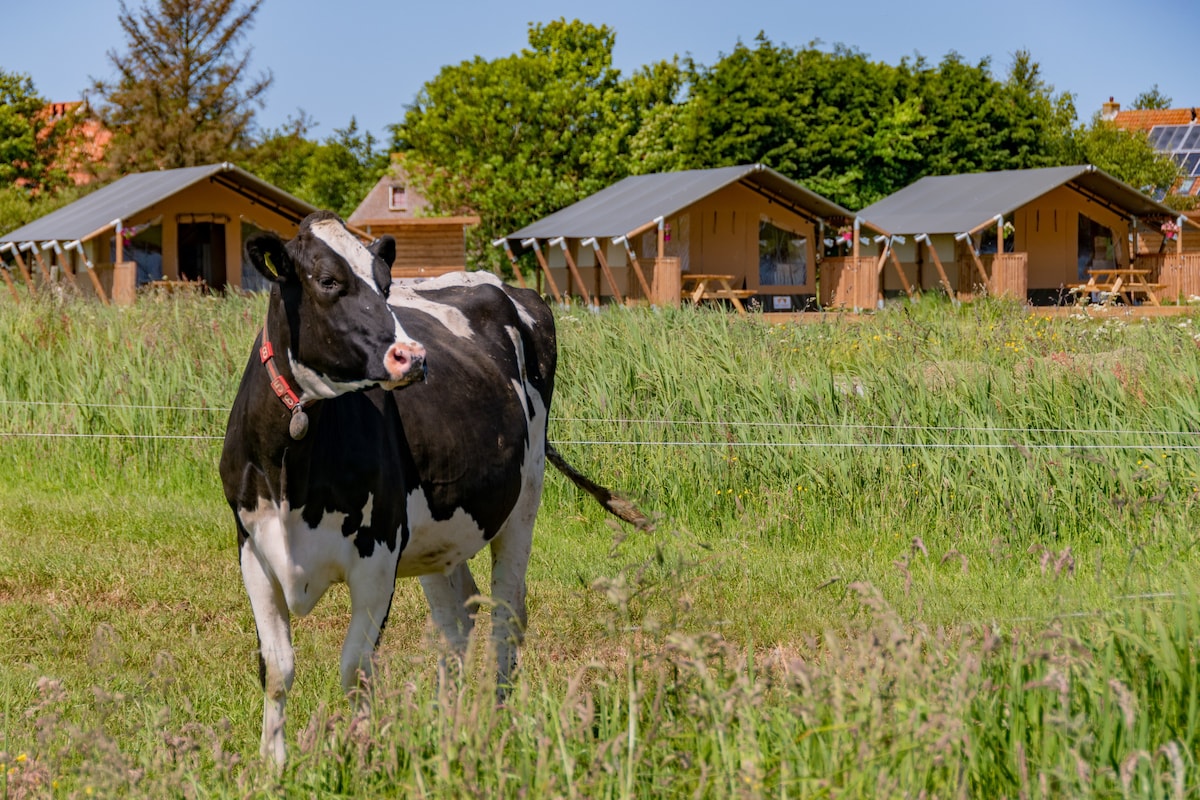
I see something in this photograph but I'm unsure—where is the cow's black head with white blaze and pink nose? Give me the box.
[246,211,425,401]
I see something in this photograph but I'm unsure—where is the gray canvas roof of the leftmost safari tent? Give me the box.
[0,163,317,242]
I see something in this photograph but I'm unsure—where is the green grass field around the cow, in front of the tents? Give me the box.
[0,291,1200,798]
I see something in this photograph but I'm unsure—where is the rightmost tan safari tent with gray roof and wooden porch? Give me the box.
[859,164,1200,305]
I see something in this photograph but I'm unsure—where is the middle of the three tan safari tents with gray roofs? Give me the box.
[497,164,876,311]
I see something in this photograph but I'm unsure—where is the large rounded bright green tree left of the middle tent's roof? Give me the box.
[392,19,678,273]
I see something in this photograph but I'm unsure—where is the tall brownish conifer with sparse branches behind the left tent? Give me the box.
[92,0,272,174]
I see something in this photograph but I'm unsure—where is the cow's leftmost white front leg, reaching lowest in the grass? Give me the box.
[241,539,295,766]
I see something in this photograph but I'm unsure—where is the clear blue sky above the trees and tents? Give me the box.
[0,0,1200,142]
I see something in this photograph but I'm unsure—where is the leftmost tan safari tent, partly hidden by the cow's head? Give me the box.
[0,163,317,303]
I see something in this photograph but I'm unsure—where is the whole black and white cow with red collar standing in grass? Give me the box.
[221,212,646,763]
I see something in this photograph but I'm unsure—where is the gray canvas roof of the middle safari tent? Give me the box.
[505,164,854,240]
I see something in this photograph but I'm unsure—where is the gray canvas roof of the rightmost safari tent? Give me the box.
[858,164,1176,235]
